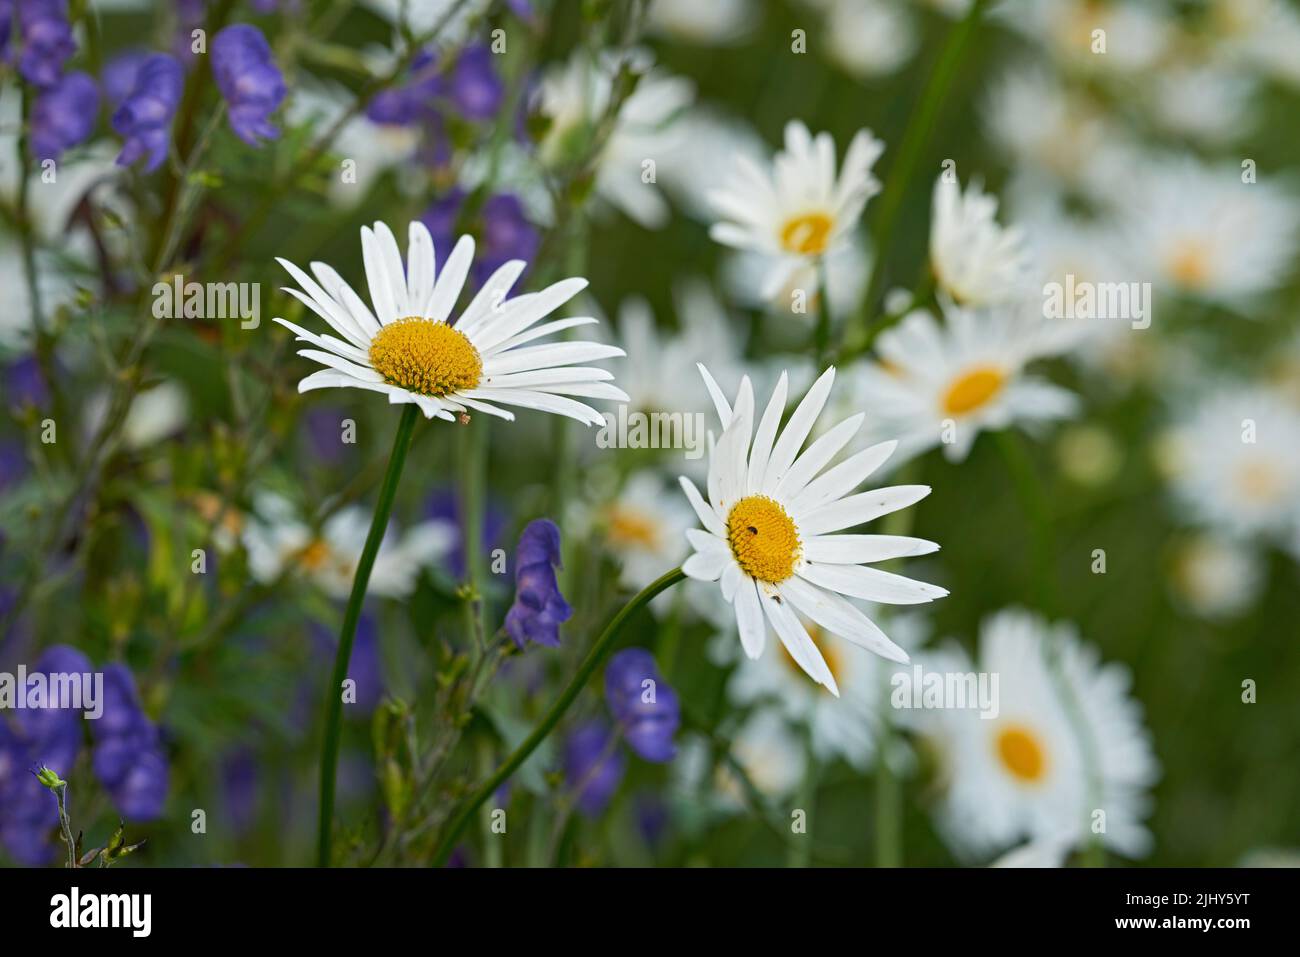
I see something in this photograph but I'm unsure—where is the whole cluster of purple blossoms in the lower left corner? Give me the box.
[0,645,168,865]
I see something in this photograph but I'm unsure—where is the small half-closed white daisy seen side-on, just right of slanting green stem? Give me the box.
[930,170,1031,306]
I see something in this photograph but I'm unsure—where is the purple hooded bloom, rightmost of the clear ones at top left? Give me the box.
[212,23,287,146]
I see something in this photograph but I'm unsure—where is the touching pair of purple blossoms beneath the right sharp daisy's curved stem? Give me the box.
[564,648,681,817]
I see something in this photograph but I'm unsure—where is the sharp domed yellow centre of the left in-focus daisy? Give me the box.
[371,316,484,395]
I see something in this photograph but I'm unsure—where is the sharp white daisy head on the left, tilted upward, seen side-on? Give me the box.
[276,222,628,425]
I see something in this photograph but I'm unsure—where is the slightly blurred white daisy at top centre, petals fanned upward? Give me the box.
[709,120,884,273]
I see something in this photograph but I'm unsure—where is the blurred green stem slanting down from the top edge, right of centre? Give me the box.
[849,0,987,355]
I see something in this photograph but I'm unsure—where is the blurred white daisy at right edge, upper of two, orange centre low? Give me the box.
[1123,159,1300,304]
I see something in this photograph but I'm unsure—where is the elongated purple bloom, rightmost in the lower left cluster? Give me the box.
[91,663,169,820]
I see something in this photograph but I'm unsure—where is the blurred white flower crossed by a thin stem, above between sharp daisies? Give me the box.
[538,51,696,229]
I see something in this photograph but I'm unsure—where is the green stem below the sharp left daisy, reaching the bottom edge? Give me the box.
[316,403,420,867]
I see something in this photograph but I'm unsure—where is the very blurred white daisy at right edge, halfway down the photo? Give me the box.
[1161,386,1300,540]
